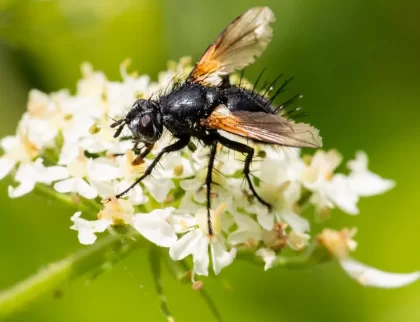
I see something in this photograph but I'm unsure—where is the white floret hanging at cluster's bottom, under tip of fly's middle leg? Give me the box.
[169,205,236,276]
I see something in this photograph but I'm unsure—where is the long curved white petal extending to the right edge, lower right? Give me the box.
[340,257,420,288]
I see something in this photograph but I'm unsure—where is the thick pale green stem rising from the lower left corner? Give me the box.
[0,234,144,321]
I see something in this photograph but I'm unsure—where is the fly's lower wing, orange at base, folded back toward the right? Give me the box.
[201,105,322,148]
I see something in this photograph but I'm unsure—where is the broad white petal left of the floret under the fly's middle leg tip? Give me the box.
[133,208,177,247]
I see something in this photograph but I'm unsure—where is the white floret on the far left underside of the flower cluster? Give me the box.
[8,158,69,198]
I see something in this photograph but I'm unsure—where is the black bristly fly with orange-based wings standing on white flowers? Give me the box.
[111,7,322,235]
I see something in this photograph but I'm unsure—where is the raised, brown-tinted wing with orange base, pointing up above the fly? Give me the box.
[188,7,275,86]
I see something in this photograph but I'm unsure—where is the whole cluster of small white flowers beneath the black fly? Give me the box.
[0,59,419,287]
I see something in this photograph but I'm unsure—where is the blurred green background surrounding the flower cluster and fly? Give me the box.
[0,0,420,322]
